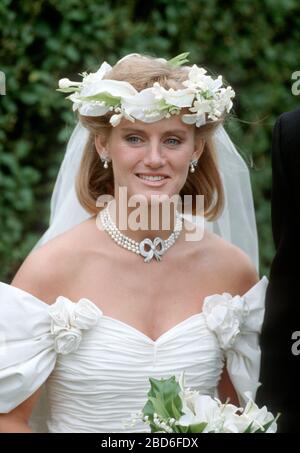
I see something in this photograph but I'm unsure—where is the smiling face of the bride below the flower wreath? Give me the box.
[95,116,204,202]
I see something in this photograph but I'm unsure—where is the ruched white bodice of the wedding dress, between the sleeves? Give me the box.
[47,314,223,432]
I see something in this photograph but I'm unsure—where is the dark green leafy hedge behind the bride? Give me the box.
[0,0,300,281]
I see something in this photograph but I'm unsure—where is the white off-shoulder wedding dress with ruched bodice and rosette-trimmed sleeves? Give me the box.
[0,277,268,433]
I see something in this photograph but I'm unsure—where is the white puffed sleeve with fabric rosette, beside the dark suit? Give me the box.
[203,277,268,405]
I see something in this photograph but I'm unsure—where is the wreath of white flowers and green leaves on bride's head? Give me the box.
[57,52,235,127]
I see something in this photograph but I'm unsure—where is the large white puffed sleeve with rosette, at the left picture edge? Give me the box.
[0,282,101,413]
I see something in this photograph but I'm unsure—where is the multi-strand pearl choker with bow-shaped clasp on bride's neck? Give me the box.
[100,206,183,263]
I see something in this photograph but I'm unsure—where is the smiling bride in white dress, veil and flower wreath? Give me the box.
[0,54,267,432]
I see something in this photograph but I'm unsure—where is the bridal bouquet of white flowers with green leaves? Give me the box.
[125,373,279,433]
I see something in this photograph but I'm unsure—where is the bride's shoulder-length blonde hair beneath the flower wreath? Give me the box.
[76,55,224,220]
